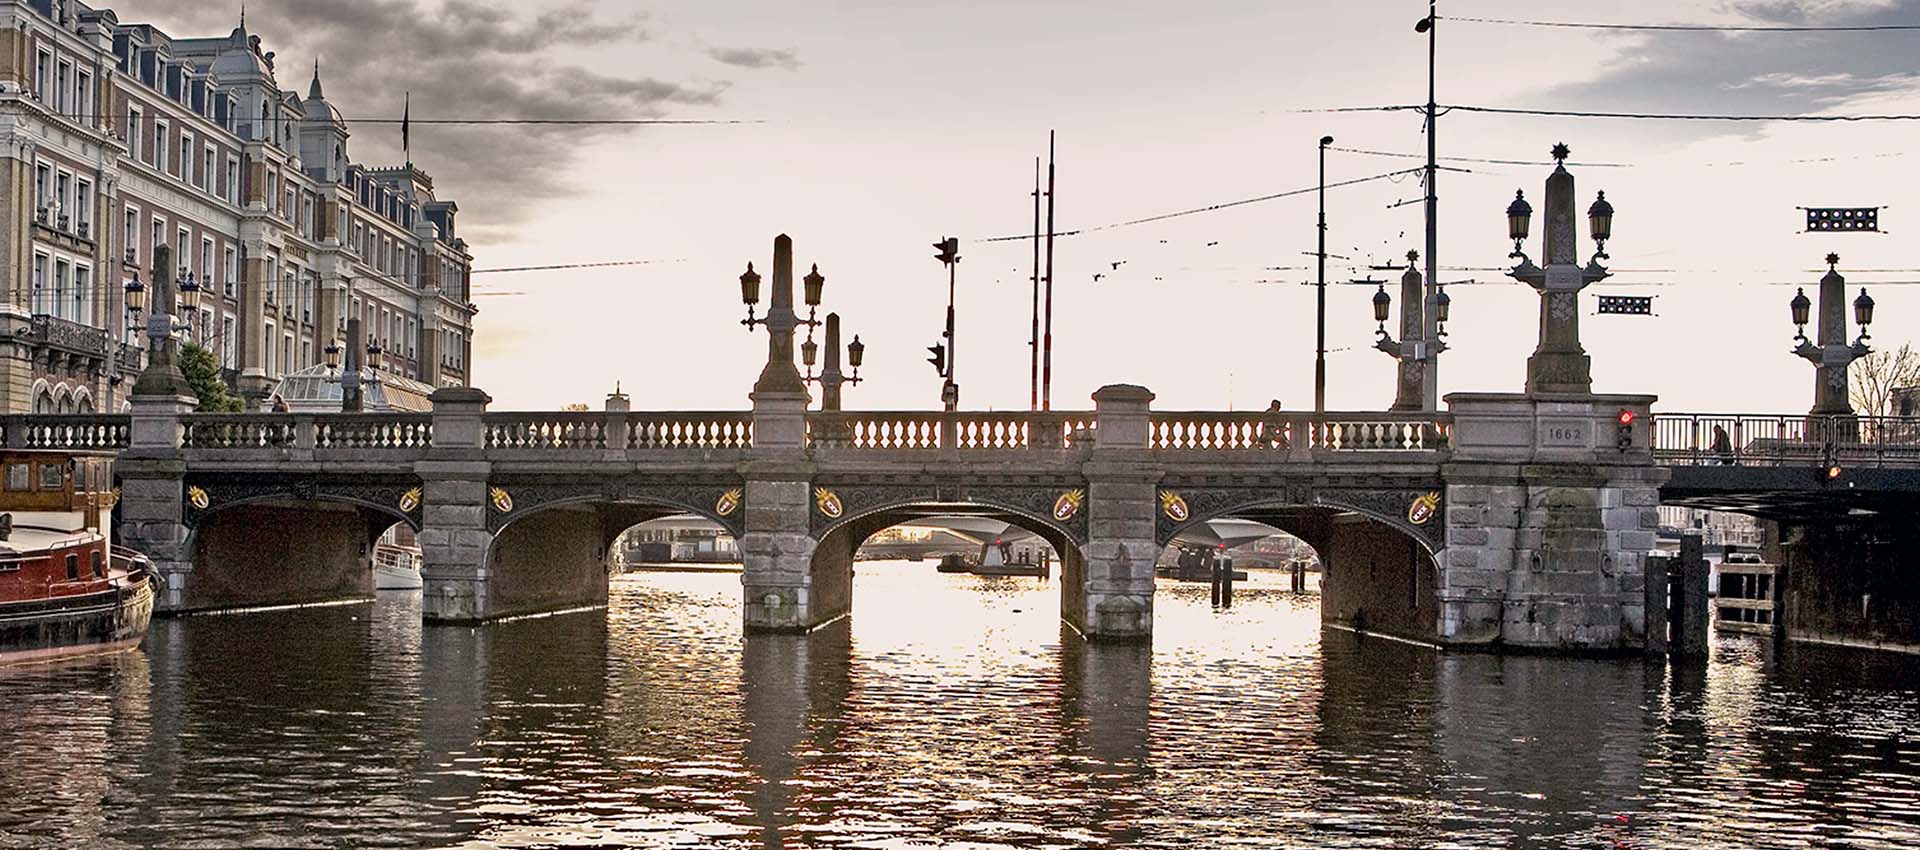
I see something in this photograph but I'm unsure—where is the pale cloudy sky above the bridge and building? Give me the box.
[127,0,1920,413]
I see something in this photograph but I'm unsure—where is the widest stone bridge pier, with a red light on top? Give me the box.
[1438,393,1667,652]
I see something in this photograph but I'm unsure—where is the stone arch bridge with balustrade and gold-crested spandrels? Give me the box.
[4,386,1668,650]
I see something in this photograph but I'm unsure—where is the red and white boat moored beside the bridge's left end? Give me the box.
[0,451,156,664]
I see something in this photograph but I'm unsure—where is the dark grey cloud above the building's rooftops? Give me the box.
[123,0,728,244]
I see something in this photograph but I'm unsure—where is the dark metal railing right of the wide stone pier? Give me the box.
[1653,413,1920,466]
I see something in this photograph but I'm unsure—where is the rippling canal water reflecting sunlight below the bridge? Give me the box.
[0,562,1920,850]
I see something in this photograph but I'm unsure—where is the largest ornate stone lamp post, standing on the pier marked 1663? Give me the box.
[1507,144,1613,393]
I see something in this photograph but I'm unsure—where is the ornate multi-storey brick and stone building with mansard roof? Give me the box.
[0,0,474,413]
